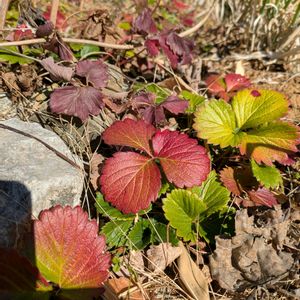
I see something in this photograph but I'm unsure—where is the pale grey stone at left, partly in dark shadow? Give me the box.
[0,119,84,247]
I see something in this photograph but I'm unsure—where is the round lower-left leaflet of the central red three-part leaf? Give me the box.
[100,152,161,214]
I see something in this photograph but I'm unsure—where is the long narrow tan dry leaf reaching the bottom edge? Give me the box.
[178,242,209,300]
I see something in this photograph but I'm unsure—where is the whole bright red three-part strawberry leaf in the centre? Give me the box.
[100,119,210,213]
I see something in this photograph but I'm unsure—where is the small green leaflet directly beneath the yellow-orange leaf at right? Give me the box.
[251,159,282,188]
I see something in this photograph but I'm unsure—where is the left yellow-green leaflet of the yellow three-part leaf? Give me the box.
[193,100,243,148]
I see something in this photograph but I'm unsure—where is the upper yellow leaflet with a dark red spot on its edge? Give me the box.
[232,89,288,130]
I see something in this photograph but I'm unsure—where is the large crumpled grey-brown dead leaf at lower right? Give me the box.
[210,208,294,291]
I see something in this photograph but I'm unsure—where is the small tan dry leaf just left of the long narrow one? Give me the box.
[147,243,181,273]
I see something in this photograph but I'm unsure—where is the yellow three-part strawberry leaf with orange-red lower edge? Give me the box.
[194,89,298,166]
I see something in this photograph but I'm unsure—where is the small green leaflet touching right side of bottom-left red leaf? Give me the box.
[100,220,133,248]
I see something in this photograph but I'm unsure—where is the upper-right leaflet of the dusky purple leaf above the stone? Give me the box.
[76,59,108,88]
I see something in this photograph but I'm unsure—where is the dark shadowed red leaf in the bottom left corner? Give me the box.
[0,248,52,299]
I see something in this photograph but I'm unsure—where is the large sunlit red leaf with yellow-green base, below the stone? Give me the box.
[34,205,110,292]
